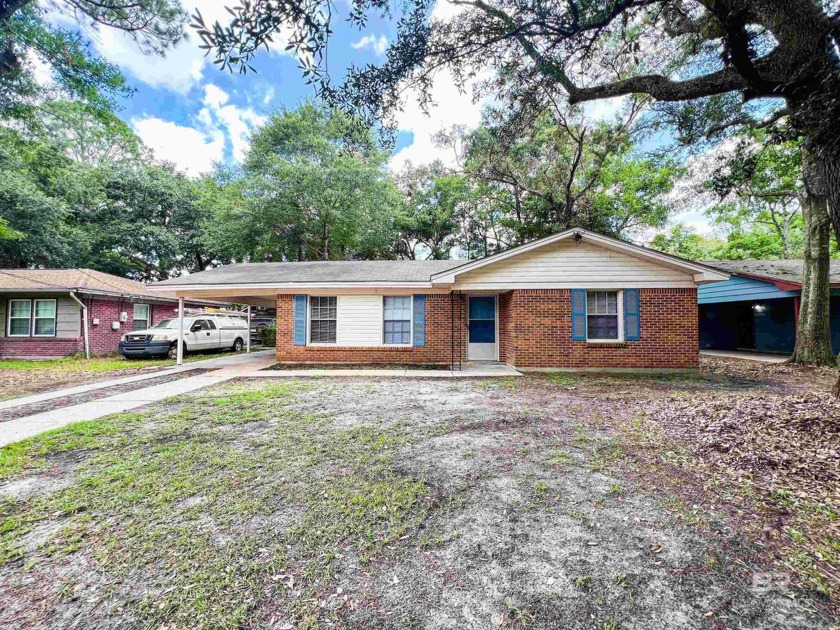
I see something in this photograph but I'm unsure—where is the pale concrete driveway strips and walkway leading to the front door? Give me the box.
[0,350,521,447]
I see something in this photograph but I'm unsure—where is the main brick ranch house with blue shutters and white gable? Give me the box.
[150,229,729,370]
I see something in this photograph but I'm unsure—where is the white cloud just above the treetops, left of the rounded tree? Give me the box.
[131,117,225,177]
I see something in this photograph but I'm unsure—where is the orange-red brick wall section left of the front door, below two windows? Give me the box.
[277,294,466,364]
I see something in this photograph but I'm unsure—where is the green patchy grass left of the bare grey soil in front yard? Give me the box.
[0,381,454,627]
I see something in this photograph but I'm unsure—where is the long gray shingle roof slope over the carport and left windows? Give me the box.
[155,260,469,287]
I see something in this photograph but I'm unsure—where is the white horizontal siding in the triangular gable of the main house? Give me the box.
[455,240,695,289]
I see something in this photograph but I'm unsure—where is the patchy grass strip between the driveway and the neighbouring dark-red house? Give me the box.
[0,353,230,400]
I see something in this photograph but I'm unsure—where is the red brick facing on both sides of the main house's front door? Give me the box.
[276,289,699,369]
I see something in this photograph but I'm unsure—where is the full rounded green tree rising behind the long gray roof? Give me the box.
[206,102,399,261]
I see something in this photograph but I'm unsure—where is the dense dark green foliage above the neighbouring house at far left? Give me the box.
[0,123,225,280]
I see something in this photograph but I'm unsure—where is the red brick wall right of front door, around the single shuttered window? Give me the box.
[500,289,699,368]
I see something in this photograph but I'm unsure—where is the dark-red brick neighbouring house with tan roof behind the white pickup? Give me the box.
[0,269,217,359]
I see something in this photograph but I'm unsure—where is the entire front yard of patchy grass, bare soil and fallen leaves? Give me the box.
[0,360,840,630]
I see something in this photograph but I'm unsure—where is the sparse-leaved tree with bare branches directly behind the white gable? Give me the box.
[440,103,680,253]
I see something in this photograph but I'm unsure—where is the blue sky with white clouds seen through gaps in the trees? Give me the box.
[46,0,709,238]
